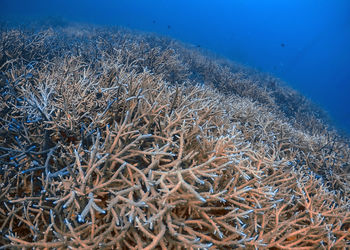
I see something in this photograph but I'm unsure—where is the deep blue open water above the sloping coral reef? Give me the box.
[0,0,350,133]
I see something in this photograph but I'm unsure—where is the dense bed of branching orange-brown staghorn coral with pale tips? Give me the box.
[0,26,350,249]
